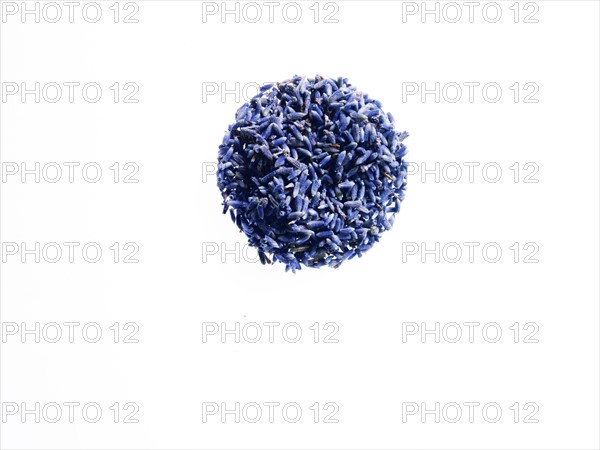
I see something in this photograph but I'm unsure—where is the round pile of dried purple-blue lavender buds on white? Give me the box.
[217,76,408,271]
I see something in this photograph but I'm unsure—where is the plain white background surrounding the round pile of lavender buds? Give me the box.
[0,1,600,449]
